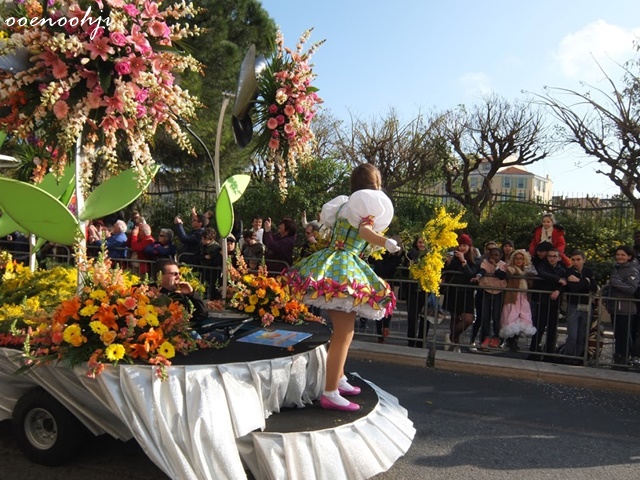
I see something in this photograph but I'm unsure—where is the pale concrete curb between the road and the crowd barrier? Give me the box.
[349,340,640,395]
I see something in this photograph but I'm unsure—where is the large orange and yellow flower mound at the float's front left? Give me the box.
[24,253,224,379]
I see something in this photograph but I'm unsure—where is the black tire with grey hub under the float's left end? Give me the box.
[13,388,89,466]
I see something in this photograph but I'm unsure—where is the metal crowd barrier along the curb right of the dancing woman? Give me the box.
[356,270,640,369]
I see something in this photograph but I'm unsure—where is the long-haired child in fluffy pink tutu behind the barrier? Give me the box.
[500,249,536,350]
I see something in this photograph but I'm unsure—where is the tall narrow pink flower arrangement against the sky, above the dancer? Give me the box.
[256,30,324,192]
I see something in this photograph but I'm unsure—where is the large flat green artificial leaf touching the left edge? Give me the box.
[0,178,81,245]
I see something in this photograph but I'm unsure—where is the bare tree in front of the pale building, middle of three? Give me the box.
[437,95,550,217]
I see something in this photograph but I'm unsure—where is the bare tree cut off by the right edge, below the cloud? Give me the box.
[539,64,640,220]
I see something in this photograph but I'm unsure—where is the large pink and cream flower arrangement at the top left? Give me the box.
[0,0,202,183]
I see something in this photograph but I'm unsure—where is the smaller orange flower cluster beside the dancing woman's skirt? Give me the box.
[227,256,324,327]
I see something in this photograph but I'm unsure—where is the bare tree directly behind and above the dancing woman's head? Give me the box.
[336,109,445,192]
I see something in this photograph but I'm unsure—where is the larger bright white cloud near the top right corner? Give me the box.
[554,20,640,83]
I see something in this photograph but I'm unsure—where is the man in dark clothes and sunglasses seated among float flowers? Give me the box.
[156,258,208,328]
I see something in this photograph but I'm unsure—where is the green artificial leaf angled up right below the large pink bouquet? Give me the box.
[79,165,160,220]
